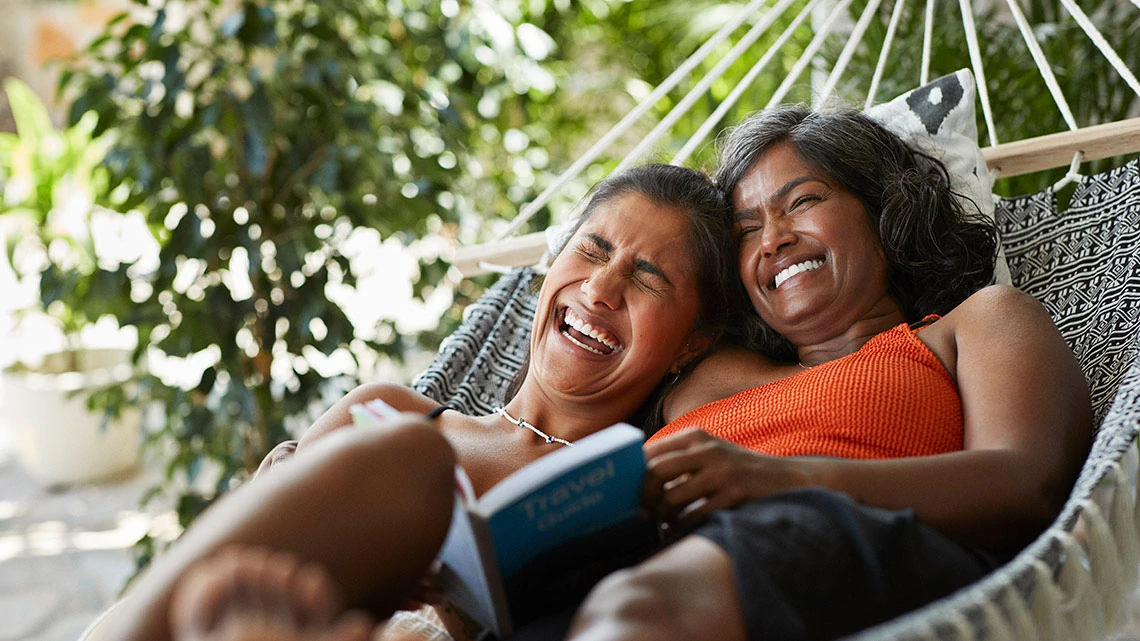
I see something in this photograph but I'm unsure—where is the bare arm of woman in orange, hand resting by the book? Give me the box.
[646,287,1091,550]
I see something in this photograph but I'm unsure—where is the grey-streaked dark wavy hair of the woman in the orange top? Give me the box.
[714,105,998,360]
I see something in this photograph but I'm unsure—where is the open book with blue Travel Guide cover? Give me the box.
[350,401,657,638]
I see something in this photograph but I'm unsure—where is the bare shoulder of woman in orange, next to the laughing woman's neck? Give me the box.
[663,347,782,422]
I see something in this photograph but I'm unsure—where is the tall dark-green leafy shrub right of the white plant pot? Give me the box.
[60,0,656,542]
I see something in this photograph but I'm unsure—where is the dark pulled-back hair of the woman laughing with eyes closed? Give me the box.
[504,164,748,433]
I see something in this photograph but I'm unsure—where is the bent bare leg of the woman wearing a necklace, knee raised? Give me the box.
[89,416,455,641]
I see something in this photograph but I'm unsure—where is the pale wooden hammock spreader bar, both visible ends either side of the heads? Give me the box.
[451,117,1140,278]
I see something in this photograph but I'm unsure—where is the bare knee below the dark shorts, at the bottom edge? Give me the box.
[567,535,746,641]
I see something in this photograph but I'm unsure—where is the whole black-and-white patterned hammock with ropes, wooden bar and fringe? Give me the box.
[414,0,1140,641]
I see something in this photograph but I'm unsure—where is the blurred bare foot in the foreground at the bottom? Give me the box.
[170,547,373,641]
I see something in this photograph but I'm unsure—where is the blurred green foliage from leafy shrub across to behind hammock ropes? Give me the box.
[46,0,1140,563]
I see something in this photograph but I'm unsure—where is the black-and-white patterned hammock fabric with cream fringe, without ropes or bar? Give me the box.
[414,161,1140,641]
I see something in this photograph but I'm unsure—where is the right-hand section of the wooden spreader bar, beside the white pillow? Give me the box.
[982,117,1140,178]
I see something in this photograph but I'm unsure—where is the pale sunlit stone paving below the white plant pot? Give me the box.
[0,432,1140,641]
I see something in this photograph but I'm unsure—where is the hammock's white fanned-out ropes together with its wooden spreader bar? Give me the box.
[453,0,1140,276]
